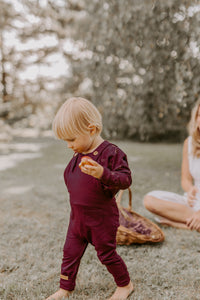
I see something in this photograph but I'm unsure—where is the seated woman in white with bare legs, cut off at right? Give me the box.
[144,99,200,232]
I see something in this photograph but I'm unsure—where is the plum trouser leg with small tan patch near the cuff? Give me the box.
[60,234,88,291]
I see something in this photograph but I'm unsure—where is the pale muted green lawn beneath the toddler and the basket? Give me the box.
[0,139,200,300]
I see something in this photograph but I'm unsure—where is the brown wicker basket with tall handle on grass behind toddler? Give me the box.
[116,188,165,245]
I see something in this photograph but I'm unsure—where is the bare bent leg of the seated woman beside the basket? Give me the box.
[144,194,194,228]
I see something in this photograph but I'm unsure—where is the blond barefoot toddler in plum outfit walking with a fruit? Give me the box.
[47,98,133,300]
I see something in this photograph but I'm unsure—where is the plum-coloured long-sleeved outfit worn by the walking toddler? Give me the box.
[60,141,132,291]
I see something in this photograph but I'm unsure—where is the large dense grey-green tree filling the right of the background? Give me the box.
[69,0,200,141]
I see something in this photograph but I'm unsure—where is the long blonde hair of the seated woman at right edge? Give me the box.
[188,99,200,157]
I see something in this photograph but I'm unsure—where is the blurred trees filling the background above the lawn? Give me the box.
[0,0,200,141]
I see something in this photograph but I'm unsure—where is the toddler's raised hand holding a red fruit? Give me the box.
[79,157,103,179]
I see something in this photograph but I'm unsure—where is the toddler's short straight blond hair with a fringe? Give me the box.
[52,97,102,140]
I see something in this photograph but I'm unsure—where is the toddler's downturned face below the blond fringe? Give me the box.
[66,131,94,153]
